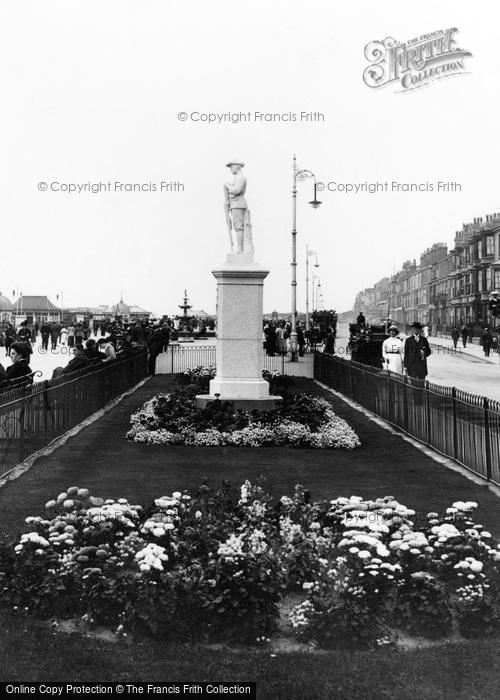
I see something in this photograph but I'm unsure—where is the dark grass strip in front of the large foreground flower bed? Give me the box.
[0,615,500,700]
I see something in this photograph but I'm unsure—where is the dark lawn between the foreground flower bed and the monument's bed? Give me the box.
[0,376,500,539]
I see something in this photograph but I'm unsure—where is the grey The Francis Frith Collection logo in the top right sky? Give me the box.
[363,27,472,92]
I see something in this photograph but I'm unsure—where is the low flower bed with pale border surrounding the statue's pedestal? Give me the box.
[127,389,361,450]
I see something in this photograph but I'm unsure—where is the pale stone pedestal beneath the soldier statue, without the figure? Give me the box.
[196,253,281,410]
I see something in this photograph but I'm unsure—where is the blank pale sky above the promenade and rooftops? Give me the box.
[0,0,500,314]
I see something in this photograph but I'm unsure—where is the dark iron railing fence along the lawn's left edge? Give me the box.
[0,351,147,476]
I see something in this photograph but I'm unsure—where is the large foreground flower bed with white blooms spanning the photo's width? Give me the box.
[0,482,500,646]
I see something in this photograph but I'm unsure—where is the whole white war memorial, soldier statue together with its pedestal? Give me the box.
[196,160,281,410]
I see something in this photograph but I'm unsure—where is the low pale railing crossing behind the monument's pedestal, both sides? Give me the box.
[156,345,314,378]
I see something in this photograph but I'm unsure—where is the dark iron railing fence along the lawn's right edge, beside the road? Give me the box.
[314,353,500,485]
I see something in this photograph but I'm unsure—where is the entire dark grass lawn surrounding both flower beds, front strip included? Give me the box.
[0,377,500,700]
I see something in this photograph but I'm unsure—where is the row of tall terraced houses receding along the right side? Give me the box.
[354,212,500,334]
